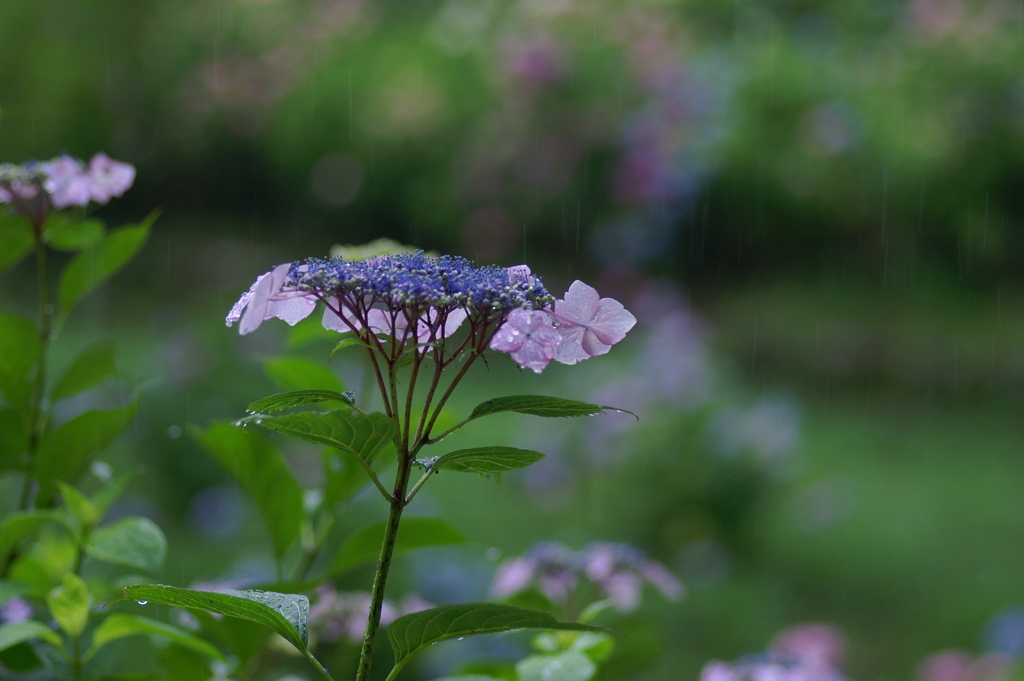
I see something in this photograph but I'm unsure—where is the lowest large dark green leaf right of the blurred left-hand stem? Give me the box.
[36,401,138,505]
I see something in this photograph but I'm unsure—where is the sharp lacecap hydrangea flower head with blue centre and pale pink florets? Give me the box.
[226,251,636,373]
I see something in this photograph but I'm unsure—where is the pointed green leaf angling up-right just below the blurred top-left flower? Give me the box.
[58,212,158,317]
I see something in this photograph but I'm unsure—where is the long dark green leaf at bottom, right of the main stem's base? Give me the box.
[387,603,606,677]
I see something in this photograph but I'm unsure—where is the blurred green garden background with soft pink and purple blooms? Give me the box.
[0,0,1024,679]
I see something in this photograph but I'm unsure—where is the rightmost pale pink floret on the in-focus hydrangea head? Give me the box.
[554,280,637,365]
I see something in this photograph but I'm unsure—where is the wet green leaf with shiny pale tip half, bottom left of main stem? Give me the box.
[114,584,309,653]
